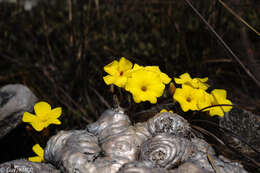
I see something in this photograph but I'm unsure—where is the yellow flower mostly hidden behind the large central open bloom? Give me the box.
[132,64,171,84]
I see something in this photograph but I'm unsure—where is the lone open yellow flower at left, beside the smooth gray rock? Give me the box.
[23,102,62,131]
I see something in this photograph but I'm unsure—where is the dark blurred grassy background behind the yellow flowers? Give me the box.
[0,0,260,172]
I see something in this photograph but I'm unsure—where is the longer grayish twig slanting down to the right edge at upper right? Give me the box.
[185,0,260,87]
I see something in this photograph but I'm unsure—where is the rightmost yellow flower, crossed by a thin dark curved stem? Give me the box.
[203,89,232,117]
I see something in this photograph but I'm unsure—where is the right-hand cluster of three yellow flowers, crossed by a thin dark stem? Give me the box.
[173,73,232,116]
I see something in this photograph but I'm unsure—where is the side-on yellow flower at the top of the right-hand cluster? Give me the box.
[174,73,209,90]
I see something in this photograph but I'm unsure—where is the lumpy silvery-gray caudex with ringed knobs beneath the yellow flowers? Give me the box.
[0,108,246,173]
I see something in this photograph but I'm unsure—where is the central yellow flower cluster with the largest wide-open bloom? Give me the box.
[103,57,171,103]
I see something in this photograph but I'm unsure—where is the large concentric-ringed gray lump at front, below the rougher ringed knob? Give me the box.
[140,133,194,169]
